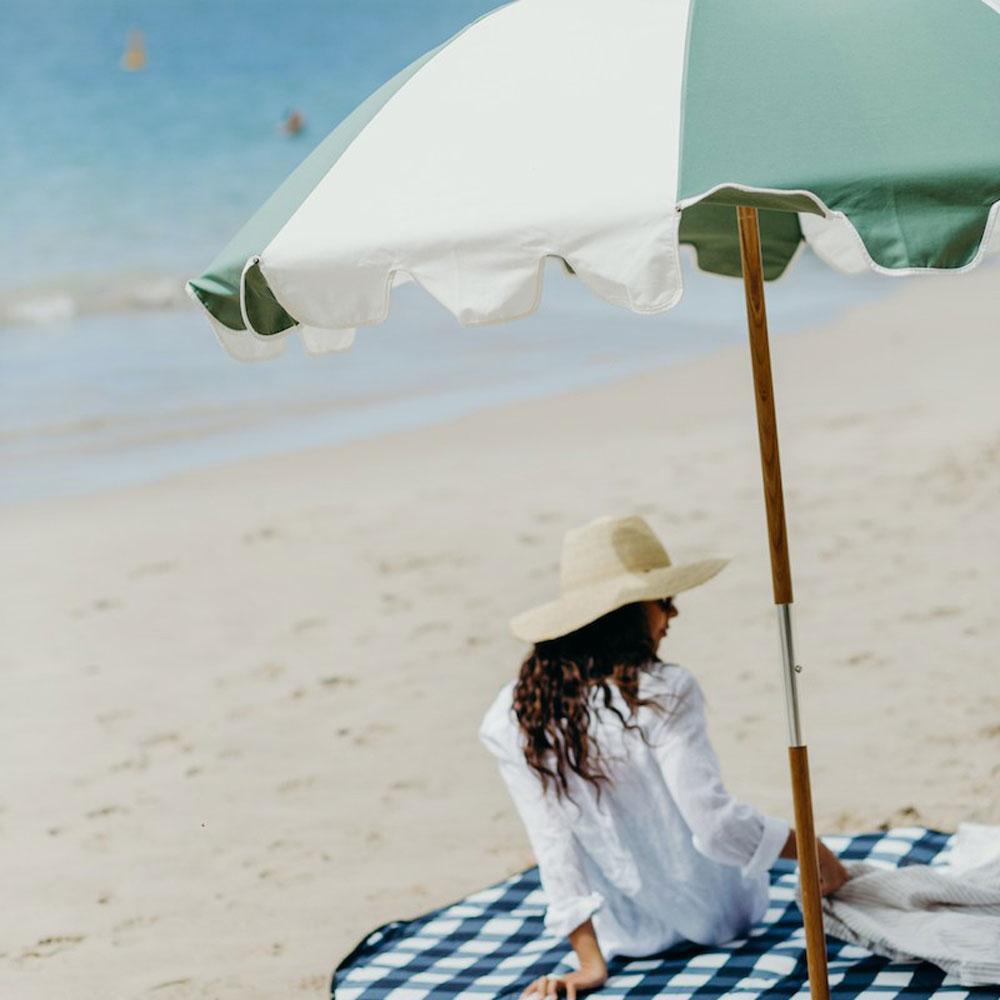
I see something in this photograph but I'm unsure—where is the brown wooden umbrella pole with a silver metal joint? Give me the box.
[736,205,830,1000]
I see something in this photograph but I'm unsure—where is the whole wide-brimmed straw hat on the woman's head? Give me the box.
[510,517,729,642]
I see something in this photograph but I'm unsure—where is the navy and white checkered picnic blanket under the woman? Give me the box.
[332,827,1000,1000]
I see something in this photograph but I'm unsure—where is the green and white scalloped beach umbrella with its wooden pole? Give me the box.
[188,0,1000,997]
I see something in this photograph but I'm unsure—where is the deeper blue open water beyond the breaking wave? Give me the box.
[0,0,497,298]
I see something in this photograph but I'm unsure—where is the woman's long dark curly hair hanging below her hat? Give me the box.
[513,604,663,798]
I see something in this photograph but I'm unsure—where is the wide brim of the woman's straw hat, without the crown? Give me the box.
[510,559,729,642]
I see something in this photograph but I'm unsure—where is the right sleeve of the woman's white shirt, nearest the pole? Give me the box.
[652,671,789,877]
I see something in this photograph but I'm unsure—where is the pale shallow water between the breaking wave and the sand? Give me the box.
[0,250,892,507]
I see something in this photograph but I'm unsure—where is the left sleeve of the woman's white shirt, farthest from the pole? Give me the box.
[479,723,604,937]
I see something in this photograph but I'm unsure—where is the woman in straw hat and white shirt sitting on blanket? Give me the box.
[480,517,847,1000]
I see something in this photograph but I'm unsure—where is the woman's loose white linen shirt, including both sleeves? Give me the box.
[479,663,789,959]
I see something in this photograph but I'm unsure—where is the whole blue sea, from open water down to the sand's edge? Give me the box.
[0,0,896,503]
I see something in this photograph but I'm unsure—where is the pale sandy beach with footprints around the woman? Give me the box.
[0,266,1000,1000]
